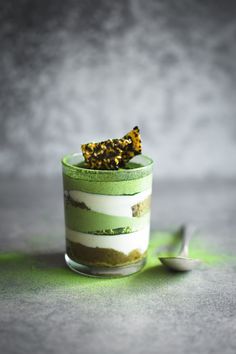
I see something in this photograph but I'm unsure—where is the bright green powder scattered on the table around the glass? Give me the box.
[0,232,236,298]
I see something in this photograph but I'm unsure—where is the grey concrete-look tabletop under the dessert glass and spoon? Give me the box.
[0,178,236,354]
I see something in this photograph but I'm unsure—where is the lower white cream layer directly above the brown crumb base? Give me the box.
[66,225,149,255]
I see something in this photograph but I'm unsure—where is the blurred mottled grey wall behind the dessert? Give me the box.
[0,0,236,178]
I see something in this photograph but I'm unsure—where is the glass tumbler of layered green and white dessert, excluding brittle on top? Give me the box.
[62,127,153,277]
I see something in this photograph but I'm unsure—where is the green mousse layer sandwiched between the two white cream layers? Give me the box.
[65,204,150,233]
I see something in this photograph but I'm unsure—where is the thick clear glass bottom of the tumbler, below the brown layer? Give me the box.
[65,254,146,278]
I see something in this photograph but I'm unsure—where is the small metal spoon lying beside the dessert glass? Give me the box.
[159,226,201,272]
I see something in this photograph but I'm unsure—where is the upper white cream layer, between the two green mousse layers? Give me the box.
[69,189,152,217]
